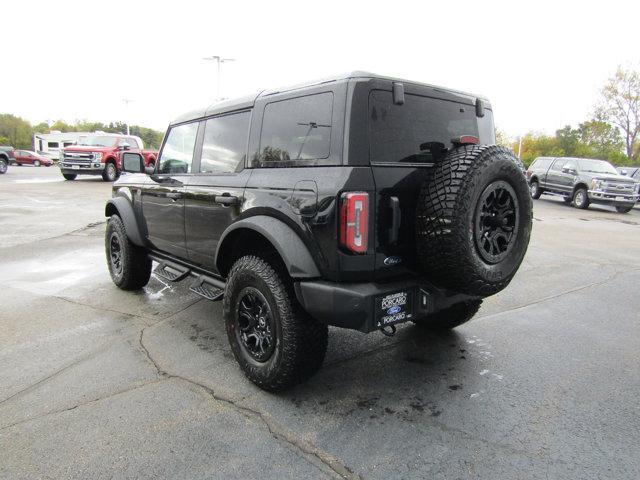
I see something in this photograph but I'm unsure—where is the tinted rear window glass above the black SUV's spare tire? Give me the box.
[369,90,495,163]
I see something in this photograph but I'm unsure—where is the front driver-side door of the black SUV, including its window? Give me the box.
[142,122,198,259]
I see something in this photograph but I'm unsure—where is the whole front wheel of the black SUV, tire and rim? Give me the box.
[104,215,151,290]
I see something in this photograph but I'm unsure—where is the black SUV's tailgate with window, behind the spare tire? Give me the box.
[368,89,495,278]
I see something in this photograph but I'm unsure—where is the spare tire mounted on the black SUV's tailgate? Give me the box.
[416,145,532,297]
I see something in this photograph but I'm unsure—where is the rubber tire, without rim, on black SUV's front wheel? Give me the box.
[105,215,152,290]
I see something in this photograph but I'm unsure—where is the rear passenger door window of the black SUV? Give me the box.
[200,112,251,173]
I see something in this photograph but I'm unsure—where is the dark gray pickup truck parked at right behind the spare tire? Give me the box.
[527,157,640,213]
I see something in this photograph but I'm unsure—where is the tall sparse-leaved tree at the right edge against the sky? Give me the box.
[596,67,640,163]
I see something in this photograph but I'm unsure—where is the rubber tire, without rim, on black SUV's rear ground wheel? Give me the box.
[222,255,328,392]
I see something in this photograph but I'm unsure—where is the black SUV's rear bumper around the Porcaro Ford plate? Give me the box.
[295,278,477,333]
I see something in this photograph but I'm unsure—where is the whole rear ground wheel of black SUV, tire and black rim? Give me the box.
[222,256,328,392]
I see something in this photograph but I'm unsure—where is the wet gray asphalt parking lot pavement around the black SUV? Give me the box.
[0,167,640,480]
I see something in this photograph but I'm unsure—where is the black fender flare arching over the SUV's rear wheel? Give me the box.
[215,215,320,278]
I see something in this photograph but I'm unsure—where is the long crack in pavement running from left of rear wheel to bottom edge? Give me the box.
[139,323,362,480]
